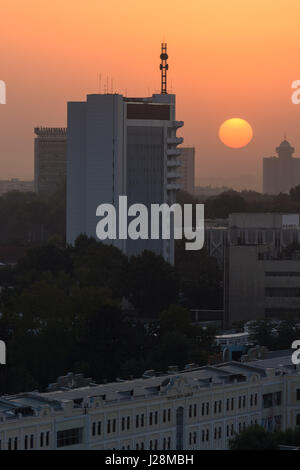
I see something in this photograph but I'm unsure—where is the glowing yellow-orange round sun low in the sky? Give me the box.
[219,118,253,148]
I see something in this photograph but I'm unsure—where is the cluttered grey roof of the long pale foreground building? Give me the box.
[0,351,299,418]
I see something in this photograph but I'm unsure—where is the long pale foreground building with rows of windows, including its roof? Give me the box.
[0,356,300,450]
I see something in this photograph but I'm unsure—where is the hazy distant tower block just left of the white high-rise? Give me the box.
[34,127,67,195]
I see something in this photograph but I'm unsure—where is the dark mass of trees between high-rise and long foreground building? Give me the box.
[0,236,218,393]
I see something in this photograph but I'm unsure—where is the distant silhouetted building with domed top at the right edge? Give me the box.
[263,140,300,194]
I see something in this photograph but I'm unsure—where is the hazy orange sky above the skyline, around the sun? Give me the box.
[0,0,300,188]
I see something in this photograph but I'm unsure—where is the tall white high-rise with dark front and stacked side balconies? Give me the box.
[67,93,183,263]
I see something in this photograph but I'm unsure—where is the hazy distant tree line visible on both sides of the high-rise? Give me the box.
[0,185,300,246]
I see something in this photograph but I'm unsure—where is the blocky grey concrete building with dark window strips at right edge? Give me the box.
[225,214,300,326]
